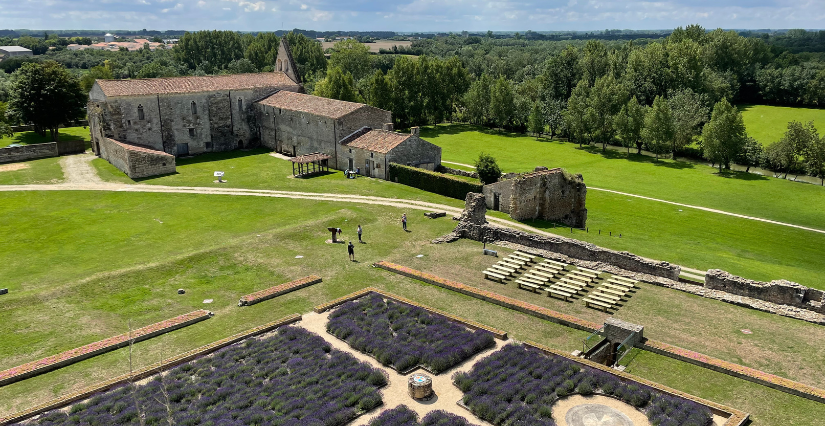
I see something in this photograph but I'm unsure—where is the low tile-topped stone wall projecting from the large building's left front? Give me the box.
[100,138,175,179]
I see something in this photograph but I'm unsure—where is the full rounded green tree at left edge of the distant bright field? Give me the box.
[702,99,748,171]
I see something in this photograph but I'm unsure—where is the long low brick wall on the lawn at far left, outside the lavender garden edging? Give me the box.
[0,309,212,387]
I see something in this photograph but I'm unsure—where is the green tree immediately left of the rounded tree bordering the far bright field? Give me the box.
[667,89,708,158]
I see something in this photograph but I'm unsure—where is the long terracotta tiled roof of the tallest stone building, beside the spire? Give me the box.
[97,72,295,96]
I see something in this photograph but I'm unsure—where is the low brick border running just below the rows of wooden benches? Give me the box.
[374,261,602,332]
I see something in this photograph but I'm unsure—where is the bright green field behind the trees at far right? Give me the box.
[738,104,825,146]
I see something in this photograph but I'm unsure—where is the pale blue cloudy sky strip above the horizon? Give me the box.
[0,0,825,32]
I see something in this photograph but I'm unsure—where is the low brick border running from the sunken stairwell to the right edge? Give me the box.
[640,340,825,403]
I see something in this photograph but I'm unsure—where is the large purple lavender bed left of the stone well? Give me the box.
[26,327,387,426]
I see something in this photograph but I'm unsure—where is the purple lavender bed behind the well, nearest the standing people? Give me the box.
[327,294,495,374]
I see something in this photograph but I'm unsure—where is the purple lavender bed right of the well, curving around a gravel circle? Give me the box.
[453,345,712,426]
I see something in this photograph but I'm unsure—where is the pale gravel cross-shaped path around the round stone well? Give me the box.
[297,311,504,426]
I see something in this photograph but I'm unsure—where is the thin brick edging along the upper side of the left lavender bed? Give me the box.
[0,314,301,426]
